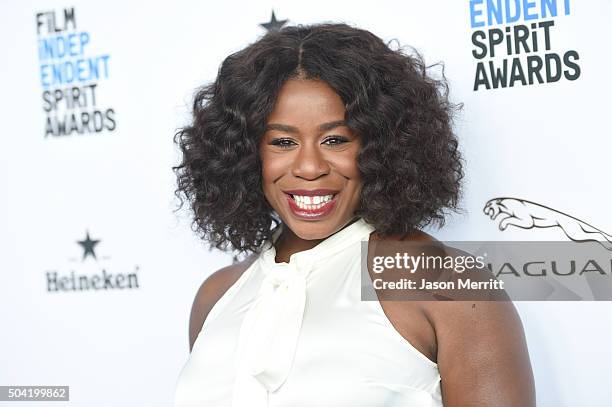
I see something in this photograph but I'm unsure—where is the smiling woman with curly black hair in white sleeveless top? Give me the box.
[175,24,534,407]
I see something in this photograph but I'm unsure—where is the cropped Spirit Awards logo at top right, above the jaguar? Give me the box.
[467,0,581,91]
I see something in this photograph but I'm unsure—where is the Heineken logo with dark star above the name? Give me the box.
[45,231,140,293]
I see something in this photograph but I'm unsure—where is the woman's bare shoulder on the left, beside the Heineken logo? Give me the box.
[189,254,257,350]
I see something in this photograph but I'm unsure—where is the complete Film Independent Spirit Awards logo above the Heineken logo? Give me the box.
[35,7,117,138]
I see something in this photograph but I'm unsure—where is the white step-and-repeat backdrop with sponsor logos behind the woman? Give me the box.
[0,0,612,407]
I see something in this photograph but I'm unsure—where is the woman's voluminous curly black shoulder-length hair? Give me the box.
[173,24,463,252]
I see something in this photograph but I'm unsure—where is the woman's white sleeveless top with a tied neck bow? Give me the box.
[174,219,442,407]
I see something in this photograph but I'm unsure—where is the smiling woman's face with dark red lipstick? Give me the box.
[260,79,361,240]
